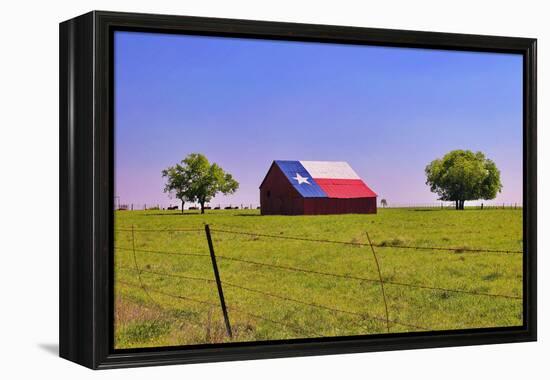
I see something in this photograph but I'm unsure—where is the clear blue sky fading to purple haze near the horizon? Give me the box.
[115,32,523,206]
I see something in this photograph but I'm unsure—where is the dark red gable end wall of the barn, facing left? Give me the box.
[260,165,304,215]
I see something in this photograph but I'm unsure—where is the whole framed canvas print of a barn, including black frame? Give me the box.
[60,11,537,369]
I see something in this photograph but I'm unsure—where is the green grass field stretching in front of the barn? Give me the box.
[115,209,523,348]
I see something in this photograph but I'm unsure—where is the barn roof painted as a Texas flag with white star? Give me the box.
[275,160,376,198]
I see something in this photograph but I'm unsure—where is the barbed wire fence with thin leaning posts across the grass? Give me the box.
[114,224,523,339]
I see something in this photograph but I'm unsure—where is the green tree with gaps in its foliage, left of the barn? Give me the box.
[162,153,239,214]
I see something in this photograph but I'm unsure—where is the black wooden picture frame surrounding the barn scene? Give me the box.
[59,11,537,369]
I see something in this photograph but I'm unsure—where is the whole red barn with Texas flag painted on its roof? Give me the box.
[260,160,377,215]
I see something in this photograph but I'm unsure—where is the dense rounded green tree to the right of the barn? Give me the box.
[425,150,502,210]
